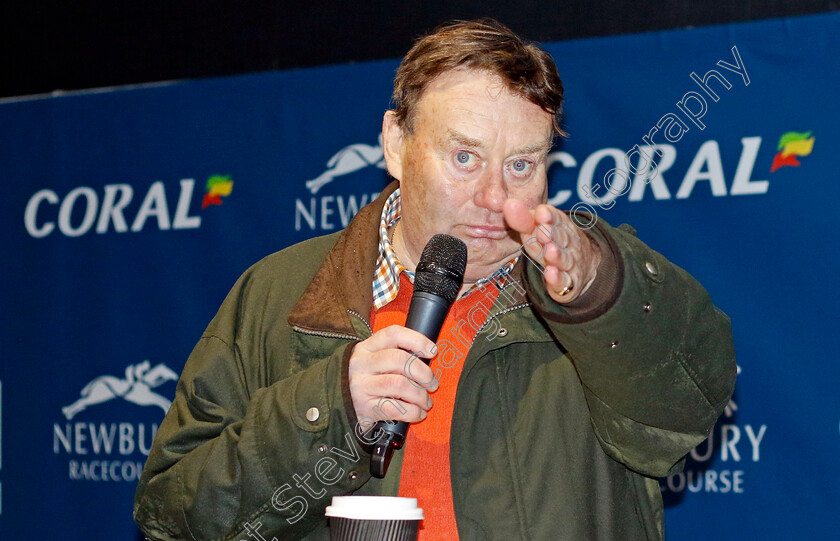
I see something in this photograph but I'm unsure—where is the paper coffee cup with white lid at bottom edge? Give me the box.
[326,496,423,541]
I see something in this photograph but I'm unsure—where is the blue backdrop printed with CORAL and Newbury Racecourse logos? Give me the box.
[0,10,840,540]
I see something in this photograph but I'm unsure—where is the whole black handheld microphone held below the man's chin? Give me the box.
[370,234,467,479]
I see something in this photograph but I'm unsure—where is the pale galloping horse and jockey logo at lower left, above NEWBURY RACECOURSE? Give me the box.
[61,361,178,421]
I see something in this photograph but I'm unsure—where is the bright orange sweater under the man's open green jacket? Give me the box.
[371,272,499,541]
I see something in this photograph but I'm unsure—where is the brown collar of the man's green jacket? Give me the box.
[288,181,525,337]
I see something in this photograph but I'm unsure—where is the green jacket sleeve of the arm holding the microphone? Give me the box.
[134,255,367,541]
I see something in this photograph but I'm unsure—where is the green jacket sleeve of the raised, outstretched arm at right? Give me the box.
[525,220,736,477]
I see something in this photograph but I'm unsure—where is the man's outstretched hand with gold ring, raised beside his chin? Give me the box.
[503,199,601,303]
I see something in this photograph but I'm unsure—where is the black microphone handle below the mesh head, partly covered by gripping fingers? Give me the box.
[370,291,451,479]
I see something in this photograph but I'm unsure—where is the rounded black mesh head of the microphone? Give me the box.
[414,234,467,303]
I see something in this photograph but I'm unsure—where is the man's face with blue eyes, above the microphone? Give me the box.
[383,69,552,283]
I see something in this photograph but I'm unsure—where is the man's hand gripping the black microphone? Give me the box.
[349,325,438,429]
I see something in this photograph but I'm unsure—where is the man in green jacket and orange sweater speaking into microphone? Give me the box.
[135,21,735,540]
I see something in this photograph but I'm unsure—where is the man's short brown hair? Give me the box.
[393,18,566,136]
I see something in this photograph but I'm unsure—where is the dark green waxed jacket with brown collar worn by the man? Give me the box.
[134,185,735,541]
